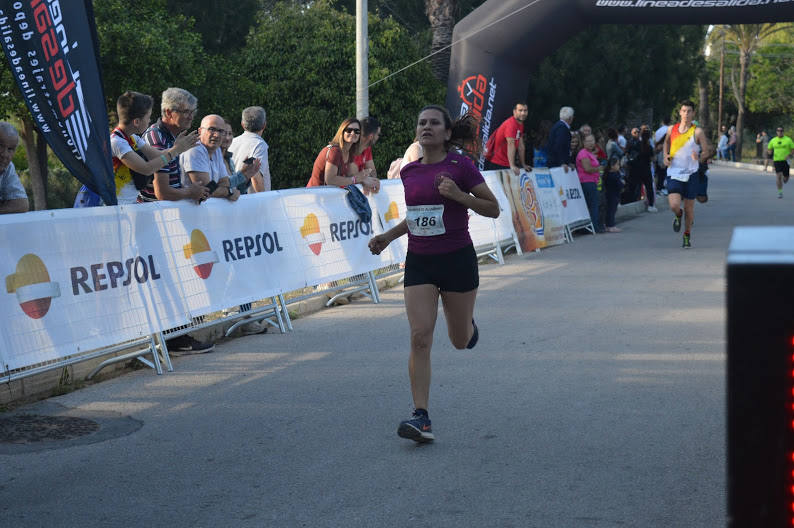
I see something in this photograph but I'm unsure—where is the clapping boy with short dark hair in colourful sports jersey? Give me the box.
[110,91,197,205]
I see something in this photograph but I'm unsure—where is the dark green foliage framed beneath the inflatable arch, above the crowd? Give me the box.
[527,25,705,128]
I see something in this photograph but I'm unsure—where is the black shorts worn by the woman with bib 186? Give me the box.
[403,245,480,293]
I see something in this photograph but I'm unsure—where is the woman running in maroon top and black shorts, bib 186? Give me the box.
[369,105,499,442]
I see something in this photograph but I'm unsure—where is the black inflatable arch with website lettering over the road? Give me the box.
[446,0,794,164]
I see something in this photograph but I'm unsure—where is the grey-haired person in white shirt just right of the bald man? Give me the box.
[229,106,272,192]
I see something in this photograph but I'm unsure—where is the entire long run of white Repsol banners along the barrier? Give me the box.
[0,184,511,371]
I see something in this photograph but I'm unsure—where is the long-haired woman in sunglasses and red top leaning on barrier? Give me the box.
[306,117,378,190]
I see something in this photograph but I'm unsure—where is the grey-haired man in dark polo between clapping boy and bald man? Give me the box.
[138,88,209,202]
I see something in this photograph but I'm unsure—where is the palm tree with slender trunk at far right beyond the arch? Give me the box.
[709,23,794,159]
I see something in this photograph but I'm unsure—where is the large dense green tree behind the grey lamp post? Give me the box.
[238,1,444,188]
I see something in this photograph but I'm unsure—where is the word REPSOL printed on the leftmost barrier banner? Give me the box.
[69,255,160,295]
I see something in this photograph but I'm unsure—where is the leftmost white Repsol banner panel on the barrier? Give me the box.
[0,207,189,369]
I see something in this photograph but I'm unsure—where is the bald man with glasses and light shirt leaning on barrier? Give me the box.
[179,114,240,202]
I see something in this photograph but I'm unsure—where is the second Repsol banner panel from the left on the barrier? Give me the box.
[150,193,296,318]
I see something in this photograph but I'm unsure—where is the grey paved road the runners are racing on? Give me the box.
[0,164,794,528]
